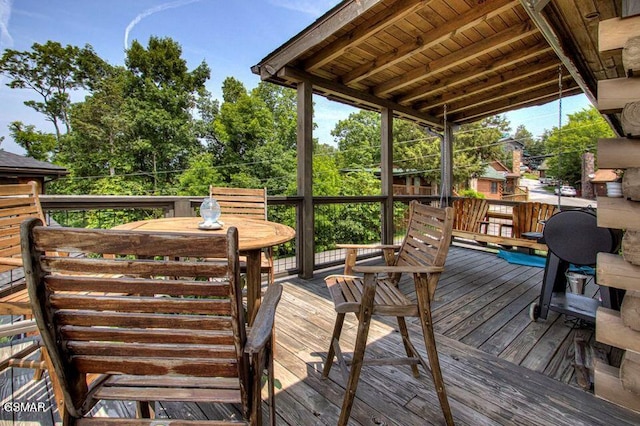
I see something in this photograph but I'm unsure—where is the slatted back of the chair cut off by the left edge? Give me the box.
[0,182,44,272]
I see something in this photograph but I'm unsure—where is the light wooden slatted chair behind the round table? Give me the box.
[209,186,275,284]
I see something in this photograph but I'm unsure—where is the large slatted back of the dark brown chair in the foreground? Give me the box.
[22,220,249,418]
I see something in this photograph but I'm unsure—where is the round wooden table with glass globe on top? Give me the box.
[113,215,296,319]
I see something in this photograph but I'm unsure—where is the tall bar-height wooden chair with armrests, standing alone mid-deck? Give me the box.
[322,201,453,425]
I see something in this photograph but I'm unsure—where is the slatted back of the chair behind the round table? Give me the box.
[210,186,267,220]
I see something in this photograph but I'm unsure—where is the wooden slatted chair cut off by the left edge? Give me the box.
[0,182,45,379]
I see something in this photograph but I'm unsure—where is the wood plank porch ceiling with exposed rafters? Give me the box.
[252,0,624,133]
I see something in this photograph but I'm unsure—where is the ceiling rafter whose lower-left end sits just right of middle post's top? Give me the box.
[396,43,553,105]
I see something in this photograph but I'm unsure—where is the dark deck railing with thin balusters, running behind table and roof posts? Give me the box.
[40,195,544,274]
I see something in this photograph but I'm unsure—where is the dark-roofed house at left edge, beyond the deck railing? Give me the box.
[0,150,69,193]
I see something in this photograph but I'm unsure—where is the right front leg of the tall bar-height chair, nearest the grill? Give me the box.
[416,280,453,426]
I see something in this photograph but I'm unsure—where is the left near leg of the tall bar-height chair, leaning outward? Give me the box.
[338,274,376,426]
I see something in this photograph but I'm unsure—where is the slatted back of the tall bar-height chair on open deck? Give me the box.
[396,201,454,297]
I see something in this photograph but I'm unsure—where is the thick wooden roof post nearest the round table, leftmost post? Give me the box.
[296,81,315,278]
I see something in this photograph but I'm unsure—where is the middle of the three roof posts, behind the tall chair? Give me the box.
[380,108,393,244]
